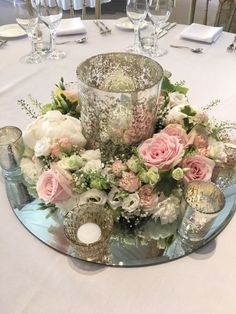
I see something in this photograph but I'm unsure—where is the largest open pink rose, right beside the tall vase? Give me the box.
[138,132,184,170]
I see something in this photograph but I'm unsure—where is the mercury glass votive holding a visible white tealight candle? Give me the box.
[64,203,113,261]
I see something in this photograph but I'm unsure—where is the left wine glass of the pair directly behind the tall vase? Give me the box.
[126,0,147,52]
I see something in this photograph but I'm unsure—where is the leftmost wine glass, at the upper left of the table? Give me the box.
[14,0,42,63]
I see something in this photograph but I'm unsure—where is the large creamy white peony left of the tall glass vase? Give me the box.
[23,110,86,155]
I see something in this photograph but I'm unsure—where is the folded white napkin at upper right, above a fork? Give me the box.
[180,23,223,43]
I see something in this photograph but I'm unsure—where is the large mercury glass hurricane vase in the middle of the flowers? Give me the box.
[77,53,163,151]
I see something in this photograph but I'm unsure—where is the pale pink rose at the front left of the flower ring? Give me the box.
[36,167,72,204]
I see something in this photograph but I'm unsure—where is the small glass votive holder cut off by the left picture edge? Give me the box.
[0,126,24,178]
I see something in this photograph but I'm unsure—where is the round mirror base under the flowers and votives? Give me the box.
[6,181,236,267]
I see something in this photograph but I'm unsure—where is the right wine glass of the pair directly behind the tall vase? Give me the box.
[147,0,173,58]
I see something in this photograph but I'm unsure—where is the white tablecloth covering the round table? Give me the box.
[0,21,236,314]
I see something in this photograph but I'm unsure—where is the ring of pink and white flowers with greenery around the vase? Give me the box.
[19,77,235,243]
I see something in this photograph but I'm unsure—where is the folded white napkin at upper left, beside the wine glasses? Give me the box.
[57,17,86,36]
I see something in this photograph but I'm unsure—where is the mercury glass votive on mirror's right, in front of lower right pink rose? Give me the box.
[178,181,225,242]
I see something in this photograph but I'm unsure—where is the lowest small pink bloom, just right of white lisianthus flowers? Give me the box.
[138,184,158,211]
